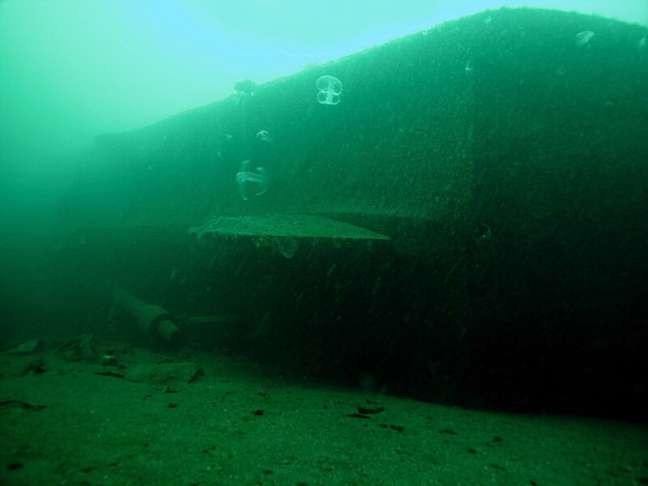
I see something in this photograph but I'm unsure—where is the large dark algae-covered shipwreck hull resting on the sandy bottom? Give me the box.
[63,9,648,416]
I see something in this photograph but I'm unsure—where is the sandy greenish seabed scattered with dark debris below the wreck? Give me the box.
[0,343,648,486]
